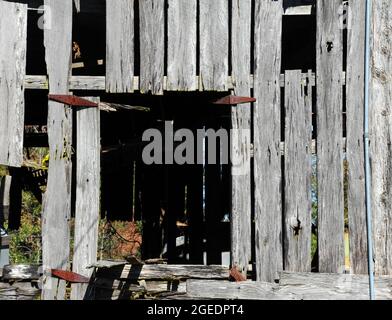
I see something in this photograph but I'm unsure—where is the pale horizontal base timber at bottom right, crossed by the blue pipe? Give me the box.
[187,272,392,300]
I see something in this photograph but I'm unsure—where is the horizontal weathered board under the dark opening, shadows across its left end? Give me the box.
[97,262,229,280]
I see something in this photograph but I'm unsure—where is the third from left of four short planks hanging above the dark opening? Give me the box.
[167,0,197,91]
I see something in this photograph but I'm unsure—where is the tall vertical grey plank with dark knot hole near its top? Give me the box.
[316,0,344,273]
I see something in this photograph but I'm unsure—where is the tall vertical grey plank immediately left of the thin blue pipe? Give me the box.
[346,1,368,274]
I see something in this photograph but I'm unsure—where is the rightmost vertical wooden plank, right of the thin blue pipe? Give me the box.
[370,0,392,275]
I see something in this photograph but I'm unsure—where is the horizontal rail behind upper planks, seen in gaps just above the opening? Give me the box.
[25,72,346,91]
